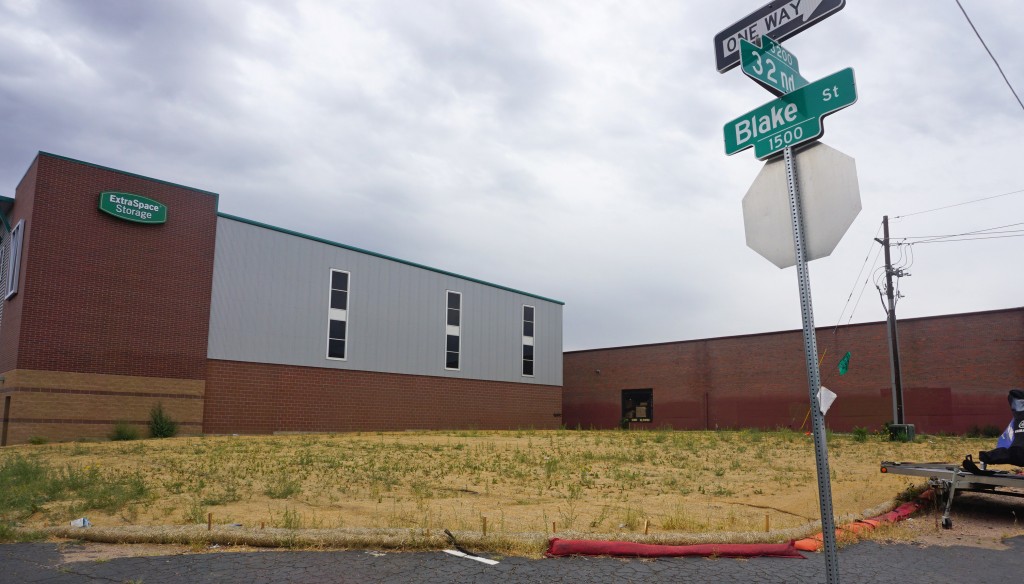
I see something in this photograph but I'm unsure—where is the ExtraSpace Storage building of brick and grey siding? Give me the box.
[0,153,562,445]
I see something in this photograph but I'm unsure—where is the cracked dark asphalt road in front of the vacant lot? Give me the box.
[0,537,1024,584]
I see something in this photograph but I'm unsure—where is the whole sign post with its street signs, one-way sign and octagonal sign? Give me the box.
[715,0,860,584]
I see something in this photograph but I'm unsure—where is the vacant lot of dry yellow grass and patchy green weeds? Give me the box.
[0,430,993,535]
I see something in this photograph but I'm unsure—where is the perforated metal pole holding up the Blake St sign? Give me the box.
[782,143,839,584]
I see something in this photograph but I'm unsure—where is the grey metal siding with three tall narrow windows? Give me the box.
[208,217,562,385]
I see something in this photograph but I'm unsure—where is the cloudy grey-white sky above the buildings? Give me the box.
[0,0,1024,349]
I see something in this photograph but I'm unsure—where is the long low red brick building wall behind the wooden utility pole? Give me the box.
[563,308,1024,432]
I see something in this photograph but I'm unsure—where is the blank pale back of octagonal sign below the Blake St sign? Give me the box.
[743,142,860,267]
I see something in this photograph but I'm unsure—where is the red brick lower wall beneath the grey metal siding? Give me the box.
[203,360,562,433]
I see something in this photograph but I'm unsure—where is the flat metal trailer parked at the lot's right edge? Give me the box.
[882,461,1024,530]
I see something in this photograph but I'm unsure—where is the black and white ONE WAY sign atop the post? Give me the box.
[715,0,846,73]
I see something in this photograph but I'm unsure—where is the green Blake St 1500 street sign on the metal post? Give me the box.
[725,69,857,159]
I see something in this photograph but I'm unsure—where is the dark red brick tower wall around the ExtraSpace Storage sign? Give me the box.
[7,153,217,379]
